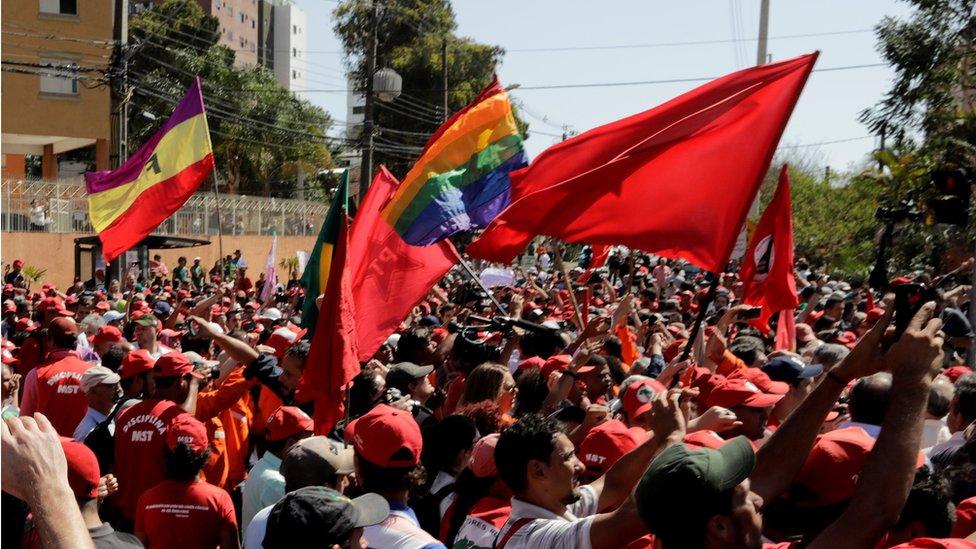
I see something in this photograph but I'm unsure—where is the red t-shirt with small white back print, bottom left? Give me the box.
[135,480,237,549]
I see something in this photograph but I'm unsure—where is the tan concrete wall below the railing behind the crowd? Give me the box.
[0,232,315,289]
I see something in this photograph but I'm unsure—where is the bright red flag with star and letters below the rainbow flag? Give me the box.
[348,166,461,360]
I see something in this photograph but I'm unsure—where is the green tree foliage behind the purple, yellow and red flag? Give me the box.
[129,0,333,196]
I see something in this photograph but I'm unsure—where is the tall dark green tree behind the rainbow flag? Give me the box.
[333,0,528,177]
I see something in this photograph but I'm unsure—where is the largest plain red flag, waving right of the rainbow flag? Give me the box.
[468,53,817,271]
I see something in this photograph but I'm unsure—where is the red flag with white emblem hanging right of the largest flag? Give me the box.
[739,164,799,331]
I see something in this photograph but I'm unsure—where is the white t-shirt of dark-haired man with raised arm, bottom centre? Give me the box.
[497,485,600,549]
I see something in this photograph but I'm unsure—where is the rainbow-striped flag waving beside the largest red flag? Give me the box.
[382,76,528,246]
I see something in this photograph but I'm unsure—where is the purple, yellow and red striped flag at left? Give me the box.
[85,77,214,262]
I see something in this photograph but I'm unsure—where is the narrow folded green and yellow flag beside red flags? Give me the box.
[302,170,349,339]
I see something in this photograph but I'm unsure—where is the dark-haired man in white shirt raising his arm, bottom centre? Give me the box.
[495,394,685,549]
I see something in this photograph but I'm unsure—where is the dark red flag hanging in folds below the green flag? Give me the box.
[300,186,360,435]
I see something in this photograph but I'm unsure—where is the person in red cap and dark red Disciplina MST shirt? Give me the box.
[115,352,203,520]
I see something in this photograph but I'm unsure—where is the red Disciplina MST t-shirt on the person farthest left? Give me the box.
[34,353,92,437]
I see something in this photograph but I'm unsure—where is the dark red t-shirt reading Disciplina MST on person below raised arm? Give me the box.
[114,399,186,519]
